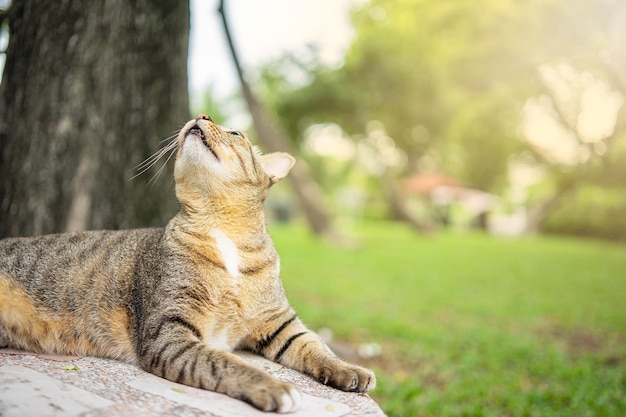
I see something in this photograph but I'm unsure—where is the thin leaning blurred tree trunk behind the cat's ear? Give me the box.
[219,0,338,240]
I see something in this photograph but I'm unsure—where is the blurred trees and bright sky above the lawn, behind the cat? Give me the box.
[190,1,626,240]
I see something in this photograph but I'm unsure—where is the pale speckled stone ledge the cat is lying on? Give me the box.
[0,350,385,417]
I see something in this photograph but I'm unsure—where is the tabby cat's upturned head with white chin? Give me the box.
[174,115,295,206]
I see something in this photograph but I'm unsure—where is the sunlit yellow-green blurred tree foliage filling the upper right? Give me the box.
[261,0,626,237]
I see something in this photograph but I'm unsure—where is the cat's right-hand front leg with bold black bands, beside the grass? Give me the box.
[256,316,376,392]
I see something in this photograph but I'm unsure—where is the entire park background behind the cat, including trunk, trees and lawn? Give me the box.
[0,0,626,416]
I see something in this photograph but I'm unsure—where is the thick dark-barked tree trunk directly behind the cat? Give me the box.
[0,0,189,236]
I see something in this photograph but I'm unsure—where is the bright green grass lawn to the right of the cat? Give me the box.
[270,223,626,417]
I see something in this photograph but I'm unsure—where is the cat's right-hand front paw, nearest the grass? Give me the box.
[313,362,376,392]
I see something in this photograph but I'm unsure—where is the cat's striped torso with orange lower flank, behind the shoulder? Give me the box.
[0,229,163,361]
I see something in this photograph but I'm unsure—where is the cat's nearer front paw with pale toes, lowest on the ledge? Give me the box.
[241,380,302,413]
